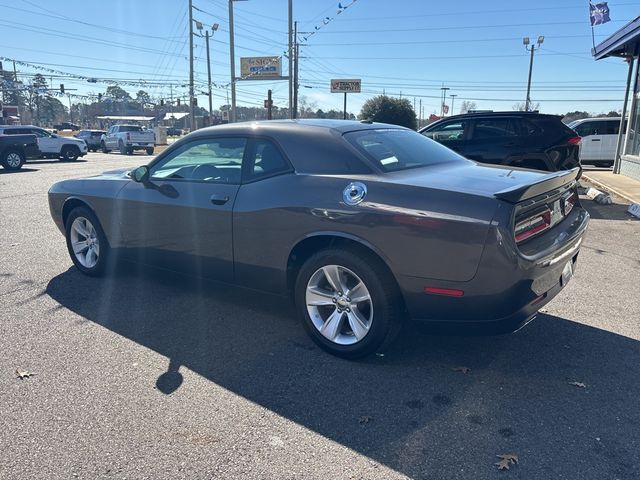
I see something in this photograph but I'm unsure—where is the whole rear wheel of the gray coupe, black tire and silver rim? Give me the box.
[295,248,404,359]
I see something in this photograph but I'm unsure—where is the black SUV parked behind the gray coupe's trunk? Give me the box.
[419,112,580,172]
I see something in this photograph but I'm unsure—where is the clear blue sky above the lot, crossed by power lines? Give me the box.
[0,0,640,116]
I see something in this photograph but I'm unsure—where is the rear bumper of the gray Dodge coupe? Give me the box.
[398,208,589,334]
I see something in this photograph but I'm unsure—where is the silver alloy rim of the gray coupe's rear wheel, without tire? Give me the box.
[306,265,373,345]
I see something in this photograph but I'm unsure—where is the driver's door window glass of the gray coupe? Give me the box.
[151,137,247,184]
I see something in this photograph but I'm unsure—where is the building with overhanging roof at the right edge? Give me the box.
[592,17,640,180]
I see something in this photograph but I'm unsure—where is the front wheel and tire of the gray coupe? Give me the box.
[65,207,111,277]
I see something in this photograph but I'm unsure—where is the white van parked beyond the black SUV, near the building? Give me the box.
[568,117,626,167]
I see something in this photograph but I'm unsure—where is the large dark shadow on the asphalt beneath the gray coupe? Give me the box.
[46,267,640,479]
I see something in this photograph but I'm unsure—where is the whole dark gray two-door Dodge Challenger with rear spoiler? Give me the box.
[49,120,589,358]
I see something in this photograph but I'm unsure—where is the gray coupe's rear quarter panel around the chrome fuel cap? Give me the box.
[233,174,498,291]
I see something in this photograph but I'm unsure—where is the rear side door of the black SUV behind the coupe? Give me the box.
[465,117,523,165]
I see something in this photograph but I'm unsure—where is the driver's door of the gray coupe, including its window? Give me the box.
[117,137,247,281]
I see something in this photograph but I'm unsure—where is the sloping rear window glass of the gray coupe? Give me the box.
[344,129,462,172]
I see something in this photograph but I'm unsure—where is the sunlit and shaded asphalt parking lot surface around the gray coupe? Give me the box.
[0,153,640,480]
